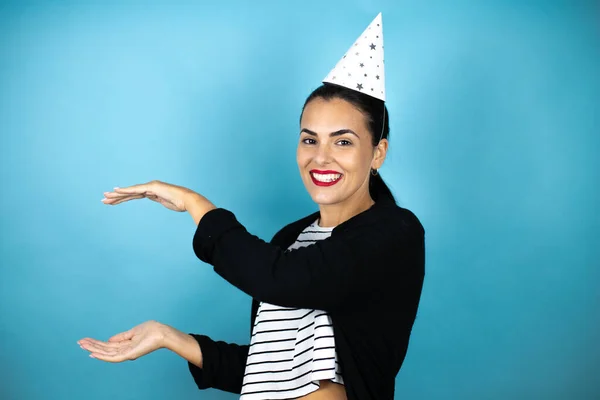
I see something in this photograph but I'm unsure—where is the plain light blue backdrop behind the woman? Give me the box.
[0,0,600,400]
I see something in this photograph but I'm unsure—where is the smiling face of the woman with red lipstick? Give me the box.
[296,98,379,205]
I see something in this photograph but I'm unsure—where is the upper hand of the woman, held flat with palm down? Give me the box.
[102,181,195,212]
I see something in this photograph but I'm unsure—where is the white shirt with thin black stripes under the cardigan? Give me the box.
[240,221,344,400]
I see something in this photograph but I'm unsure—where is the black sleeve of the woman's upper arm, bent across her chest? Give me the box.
[193,209,418,312]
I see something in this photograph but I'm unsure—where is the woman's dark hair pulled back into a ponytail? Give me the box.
[300,83,396,202]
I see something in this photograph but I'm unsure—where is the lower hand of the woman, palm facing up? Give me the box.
[77,321,167,363]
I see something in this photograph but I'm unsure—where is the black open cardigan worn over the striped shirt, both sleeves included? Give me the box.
[188,200,425,400]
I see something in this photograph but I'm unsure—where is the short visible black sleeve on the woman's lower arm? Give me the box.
[188,334,249,394]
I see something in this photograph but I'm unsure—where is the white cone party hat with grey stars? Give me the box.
[323,13,385,101]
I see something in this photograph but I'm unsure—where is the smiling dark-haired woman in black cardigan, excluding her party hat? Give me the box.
[78,14,424,400]
